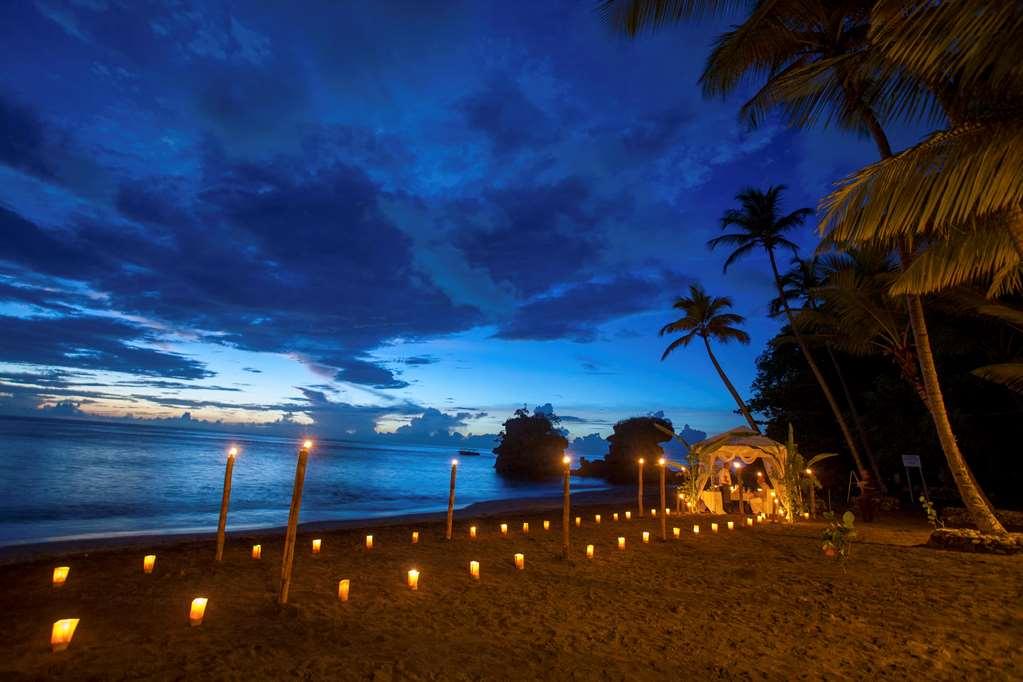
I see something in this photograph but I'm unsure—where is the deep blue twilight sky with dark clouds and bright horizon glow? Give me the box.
[0,0,892,440]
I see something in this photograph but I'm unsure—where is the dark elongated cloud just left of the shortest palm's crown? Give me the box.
[495,273,687,343]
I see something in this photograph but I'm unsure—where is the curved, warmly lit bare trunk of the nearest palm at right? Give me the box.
[864,110,1015,535]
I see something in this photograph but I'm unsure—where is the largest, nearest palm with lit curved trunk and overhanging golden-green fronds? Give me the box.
[608,0,1006,534]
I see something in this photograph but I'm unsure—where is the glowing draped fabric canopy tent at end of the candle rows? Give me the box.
[691,426,789,517]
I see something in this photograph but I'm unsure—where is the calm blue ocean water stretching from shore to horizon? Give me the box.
[0,417,604,545]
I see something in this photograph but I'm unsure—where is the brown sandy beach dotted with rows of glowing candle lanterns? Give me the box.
[0,492,1023,680]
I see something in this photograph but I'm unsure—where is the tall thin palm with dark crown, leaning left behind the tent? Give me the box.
[707,185,868,476]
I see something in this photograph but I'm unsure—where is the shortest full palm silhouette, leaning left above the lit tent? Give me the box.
[661,284,760,434]
